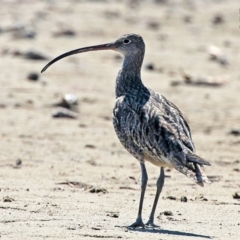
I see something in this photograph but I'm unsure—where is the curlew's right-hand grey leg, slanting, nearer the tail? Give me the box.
[146,167,165,227]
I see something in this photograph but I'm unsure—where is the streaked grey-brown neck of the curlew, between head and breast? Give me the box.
[116,53,146,97]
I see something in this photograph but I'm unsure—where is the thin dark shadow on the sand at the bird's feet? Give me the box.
[116,226,213,239]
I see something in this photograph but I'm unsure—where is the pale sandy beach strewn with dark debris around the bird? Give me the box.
[0,0,240,240]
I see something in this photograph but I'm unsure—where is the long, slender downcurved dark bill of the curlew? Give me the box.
[41,42,116,73]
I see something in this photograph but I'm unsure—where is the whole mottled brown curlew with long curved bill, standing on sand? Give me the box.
[41,33,211,228]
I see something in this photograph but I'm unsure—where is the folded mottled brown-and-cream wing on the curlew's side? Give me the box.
[129,90,209,166]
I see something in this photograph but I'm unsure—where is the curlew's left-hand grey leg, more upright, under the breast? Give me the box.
[129,162,148,228]
